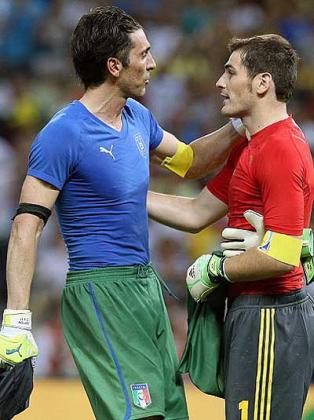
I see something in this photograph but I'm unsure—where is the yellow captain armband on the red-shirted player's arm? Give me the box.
[258,230,303,267]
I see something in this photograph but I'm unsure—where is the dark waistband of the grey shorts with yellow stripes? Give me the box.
[230,289,309,310]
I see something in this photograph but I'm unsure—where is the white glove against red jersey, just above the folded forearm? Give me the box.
[220,210,265,257]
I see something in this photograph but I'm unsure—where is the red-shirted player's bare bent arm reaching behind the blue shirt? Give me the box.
[147,187,228,233]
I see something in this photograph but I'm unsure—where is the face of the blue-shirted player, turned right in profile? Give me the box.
[118,29,156,97]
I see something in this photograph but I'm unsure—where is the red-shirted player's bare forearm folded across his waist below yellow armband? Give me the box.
[224,248,293,283]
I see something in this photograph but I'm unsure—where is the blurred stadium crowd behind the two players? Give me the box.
[0,0,314,377]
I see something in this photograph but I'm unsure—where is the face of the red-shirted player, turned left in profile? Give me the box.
[216,50,255,118]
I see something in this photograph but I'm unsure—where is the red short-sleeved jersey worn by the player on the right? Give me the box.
[207,117,314,296]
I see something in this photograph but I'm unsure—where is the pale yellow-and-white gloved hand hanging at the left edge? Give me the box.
[0,309,38,368]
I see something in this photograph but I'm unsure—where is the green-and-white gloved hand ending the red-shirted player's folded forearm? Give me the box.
[186,253,230,302]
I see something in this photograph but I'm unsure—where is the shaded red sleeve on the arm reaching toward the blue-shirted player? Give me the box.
[207,138,247,205]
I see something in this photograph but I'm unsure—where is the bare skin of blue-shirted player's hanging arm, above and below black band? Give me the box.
[7,176,59,309]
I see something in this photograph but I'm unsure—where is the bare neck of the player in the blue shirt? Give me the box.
[80,83,126,130]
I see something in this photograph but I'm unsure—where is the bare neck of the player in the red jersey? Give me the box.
[242,102,288,135]
